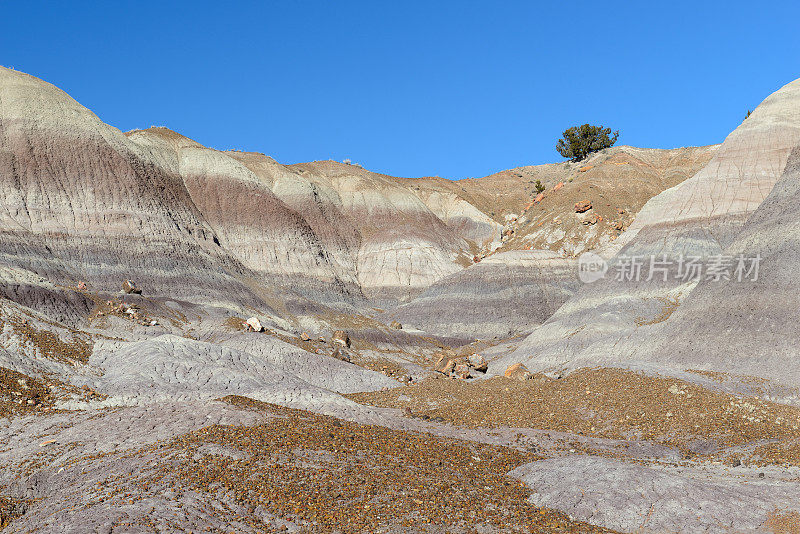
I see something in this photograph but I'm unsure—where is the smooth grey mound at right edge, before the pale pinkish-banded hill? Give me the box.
[639,149,800,386]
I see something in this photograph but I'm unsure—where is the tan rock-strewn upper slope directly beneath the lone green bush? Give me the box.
[451,145,718,257]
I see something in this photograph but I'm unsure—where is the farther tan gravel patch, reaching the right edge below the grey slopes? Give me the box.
[349,369,800,455]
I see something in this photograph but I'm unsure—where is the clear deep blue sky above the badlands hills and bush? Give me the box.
[0,0,800,178]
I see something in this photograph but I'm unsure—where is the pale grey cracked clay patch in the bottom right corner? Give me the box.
[511,456,800,534]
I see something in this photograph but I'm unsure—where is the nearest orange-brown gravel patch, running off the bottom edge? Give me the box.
[144,396,608,533]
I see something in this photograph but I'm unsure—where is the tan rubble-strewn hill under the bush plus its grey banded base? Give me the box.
[378,150,717,339]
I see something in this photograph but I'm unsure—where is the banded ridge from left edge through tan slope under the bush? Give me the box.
[0,63,715,335]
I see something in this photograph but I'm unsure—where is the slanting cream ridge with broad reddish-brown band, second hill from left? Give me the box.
[128,128,360,308]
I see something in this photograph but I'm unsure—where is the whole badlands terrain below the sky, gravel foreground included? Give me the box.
[0,68,800,533]
